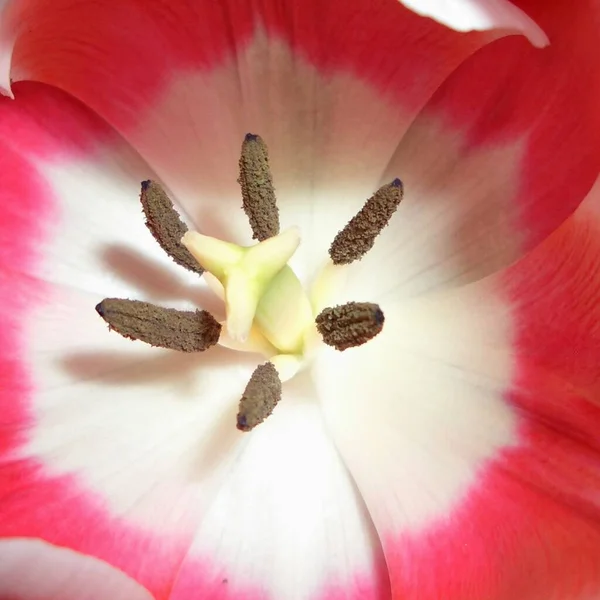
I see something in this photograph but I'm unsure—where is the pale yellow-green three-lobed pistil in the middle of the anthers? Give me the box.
[182,228,315,380]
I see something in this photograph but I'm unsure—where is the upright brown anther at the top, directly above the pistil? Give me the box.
[238,133,279,242]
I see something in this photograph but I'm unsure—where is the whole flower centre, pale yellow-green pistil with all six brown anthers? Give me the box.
[96,134,403,431]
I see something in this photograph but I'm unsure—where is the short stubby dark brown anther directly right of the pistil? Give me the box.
[316,302,385,352]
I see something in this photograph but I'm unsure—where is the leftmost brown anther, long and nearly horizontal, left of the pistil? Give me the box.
[96,298,221,352]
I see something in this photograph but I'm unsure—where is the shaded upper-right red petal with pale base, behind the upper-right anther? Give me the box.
[385,0,600,284]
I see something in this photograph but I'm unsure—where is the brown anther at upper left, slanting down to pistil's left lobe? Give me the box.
[140,180,204,275]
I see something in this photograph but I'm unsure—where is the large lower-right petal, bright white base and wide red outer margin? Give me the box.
[317,182,600,600]
